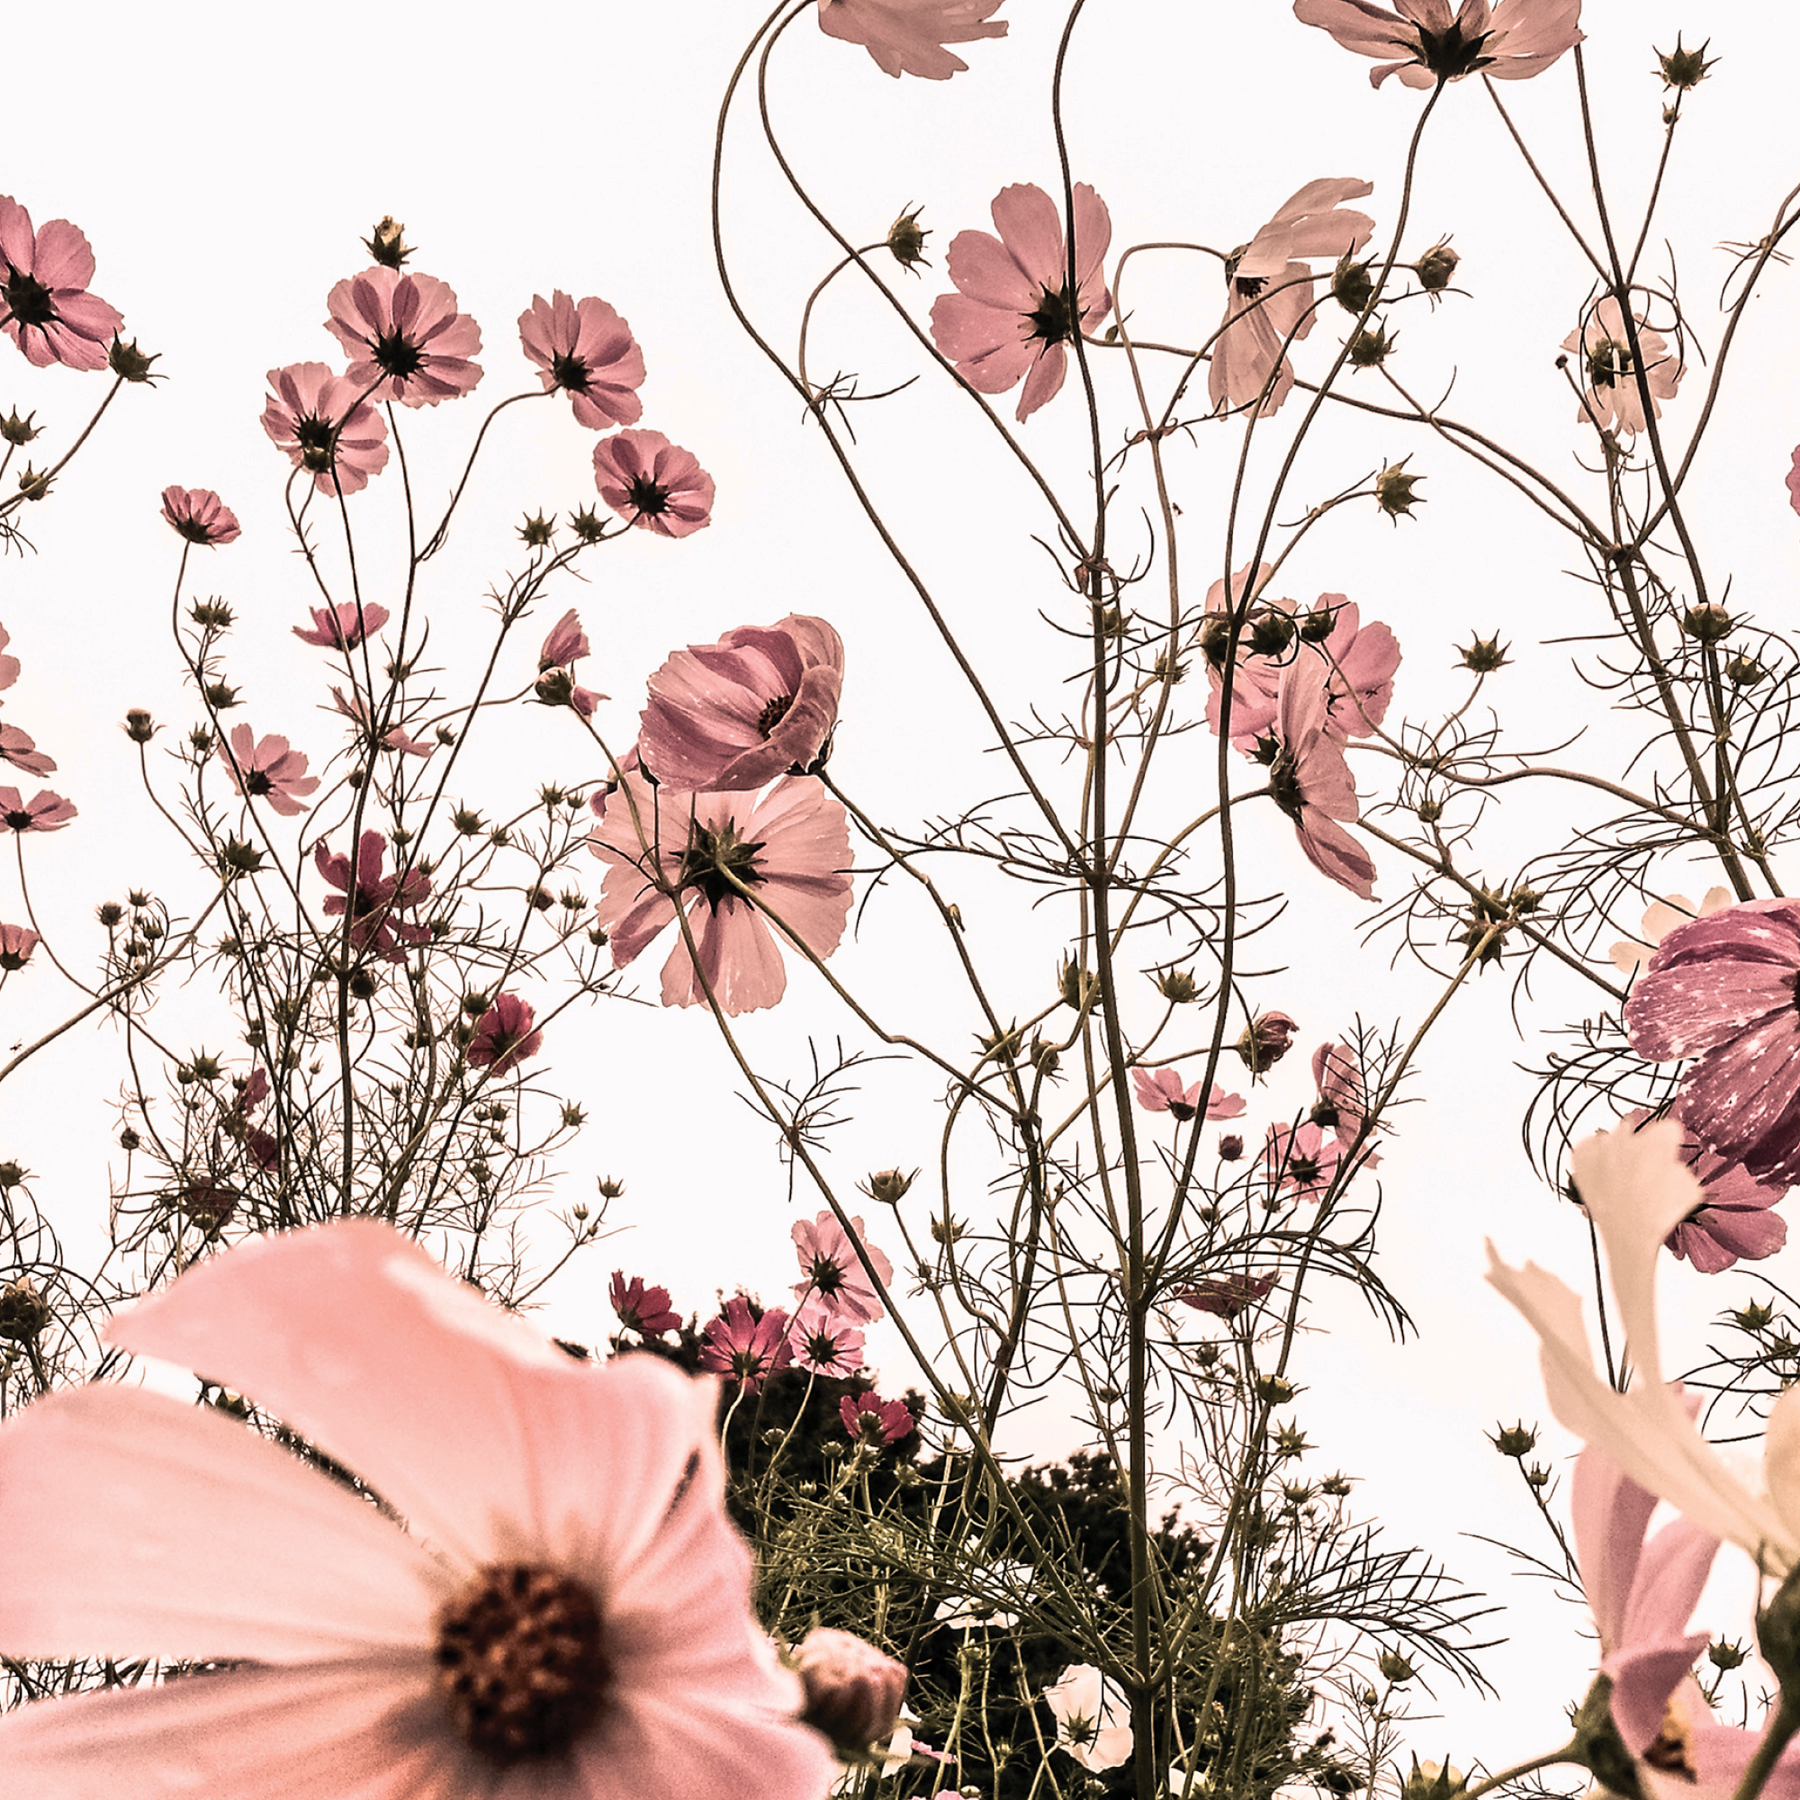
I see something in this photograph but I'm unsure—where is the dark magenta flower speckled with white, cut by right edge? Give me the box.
[1627,896,1800,1186]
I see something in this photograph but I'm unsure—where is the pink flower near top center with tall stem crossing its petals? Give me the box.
[931,182,1112,419]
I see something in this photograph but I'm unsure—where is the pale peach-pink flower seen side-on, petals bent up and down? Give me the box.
[1206,178,1375,418]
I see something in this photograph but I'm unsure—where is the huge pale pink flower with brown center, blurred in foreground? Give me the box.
[0,1219,832,1800]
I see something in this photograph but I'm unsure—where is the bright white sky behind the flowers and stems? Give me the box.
[0,0,1800,1766]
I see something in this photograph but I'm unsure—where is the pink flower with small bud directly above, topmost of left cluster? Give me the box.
[326,263,481,407]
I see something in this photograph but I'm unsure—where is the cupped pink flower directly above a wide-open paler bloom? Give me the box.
[637,612,844,794]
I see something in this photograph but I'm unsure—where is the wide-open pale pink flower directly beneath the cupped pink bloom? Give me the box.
[589,769,851,1013]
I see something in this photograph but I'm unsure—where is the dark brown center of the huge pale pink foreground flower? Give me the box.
[434,1562,612,1769]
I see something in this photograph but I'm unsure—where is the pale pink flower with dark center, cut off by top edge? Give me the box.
[1294,0,1582,88]
